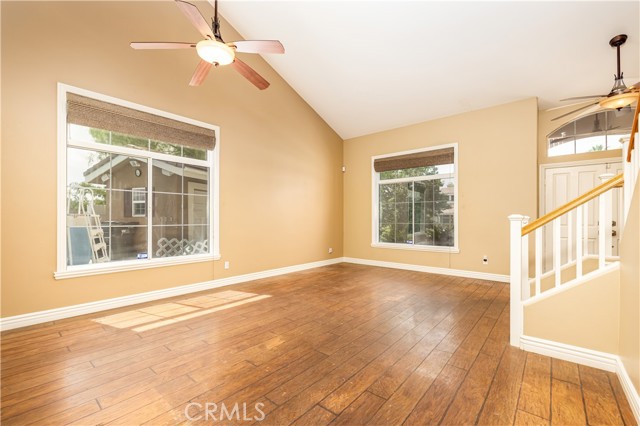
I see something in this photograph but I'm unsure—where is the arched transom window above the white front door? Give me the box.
[547,107,633,157]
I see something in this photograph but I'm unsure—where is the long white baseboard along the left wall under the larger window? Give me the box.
[0,257,343,331]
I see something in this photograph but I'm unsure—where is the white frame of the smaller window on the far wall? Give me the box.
[371,143,460,253]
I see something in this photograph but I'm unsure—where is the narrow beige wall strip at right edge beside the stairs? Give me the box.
[619,176,640,392]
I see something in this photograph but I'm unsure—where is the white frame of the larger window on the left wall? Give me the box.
[54,83,221,279]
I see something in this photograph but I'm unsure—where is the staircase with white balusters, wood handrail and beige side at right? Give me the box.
[509,106,640,421]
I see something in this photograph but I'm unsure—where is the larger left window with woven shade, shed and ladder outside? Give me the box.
[56,85,219,278]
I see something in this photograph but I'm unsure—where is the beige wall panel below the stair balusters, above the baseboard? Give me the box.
[524,269,620,354]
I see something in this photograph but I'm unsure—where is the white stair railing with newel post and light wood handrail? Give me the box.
[509,174,624,346]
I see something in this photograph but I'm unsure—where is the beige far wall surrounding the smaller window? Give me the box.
[344,98,538,275]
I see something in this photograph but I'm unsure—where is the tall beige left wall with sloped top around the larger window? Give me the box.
[1,1,343,317]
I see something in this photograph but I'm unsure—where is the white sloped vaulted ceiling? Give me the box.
[216,0,640,139]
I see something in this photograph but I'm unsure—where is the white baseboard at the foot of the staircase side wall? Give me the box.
[520,335,640,424]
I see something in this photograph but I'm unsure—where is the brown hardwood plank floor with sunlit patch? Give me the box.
[0,264,636,426]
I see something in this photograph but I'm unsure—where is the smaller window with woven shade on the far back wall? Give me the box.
[372,144,458,252]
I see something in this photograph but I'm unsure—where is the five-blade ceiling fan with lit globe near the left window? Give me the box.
[131,0,284,90]
